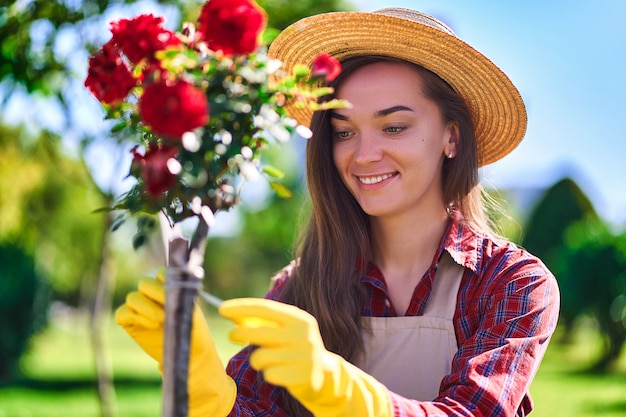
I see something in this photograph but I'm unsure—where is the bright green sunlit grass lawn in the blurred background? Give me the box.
[0,308,626,417]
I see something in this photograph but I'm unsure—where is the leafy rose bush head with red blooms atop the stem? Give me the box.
[85,0,345,245]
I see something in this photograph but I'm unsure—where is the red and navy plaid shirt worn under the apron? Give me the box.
[227,221,559,417]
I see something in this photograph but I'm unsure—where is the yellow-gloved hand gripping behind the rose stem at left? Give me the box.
[115,274,237,417]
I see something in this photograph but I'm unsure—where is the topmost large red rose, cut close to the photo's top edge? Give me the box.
[198,0,266,55]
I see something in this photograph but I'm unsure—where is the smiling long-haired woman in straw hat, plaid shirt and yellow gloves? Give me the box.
[117,9,559,416]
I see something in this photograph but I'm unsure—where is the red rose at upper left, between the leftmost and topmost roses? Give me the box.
[111,14,181,63]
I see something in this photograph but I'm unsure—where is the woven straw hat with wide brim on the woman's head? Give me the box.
[269,8,527,166]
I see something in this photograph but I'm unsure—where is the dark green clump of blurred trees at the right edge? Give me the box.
[522,178,626,369]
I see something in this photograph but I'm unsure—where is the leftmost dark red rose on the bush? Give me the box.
[85,42,137,104]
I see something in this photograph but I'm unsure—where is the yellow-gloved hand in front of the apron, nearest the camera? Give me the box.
[219,298,391,417]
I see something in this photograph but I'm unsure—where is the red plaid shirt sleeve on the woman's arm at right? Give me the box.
[390,244,559,417]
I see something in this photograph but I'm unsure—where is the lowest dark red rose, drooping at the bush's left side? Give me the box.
[131,145,178,198]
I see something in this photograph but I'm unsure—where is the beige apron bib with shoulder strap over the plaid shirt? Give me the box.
[359,251,464,401]
